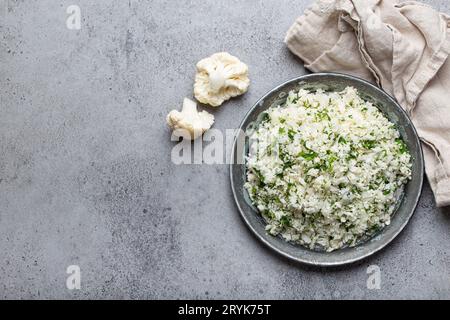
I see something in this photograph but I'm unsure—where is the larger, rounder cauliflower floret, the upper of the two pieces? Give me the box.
[194,52,250,107]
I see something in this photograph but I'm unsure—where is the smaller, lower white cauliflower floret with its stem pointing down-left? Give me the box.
[167,98,214,140]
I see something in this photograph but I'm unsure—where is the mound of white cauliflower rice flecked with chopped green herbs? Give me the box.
[245,87,411,251]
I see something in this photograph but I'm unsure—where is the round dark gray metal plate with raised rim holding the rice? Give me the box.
[230,73,424,266]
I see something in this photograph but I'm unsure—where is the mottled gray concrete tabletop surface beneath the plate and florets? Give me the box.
[0,0,450,299]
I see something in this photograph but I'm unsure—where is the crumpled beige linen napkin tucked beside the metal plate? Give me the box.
[285,0,450,207]
